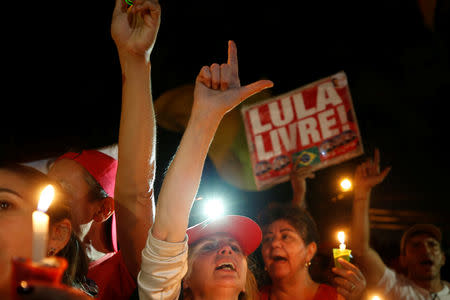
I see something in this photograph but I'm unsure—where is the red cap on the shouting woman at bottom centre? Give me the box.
[186,215,262,255]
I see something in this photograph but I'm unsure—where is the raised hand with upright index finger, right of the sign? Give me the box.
[353,149,391,192]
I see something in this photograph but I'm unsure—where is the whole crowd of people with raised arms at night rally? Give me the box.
[0,0,450,300]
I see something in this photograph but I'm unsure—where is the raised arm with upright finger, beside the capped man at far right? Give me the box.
[351,149,391,285]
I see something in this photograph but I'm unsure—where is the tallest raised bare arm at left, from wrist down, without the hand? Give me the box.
[115,53,156,276]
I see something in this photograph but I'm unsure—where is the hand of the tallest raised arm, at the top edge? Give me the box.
[111,0,161,60]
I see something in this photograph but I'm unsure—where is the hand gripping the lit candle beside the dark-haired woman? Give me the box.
[331,258,367,300]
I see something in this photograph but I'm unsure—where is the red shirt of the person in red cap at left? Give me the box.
[87,251,136,300]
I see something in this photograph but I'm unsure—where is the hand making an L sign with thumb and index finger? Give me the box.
[192,41,273,121]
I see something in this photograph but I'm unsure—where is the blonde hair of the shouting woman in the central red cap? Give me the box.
[181,243,259,300]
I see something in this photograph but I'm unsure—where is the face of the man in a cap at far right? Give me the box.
[403,234,445,280]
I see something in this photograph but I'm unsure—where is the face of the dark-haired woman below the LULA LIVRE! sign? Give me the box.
[261,220,316,280]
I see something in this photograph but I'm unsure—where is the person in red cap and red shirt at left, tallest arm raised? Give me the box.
[49,0,161,300]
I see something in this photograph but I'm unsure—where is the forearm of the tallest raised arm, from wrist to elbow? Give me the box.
[116,57,156,203]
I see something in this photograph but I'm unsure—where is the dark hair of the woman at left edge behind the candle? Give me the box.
[0,163,89,285]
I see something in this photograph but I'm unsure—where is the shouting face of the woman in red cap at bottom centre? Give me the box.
[185,234,247,295]
